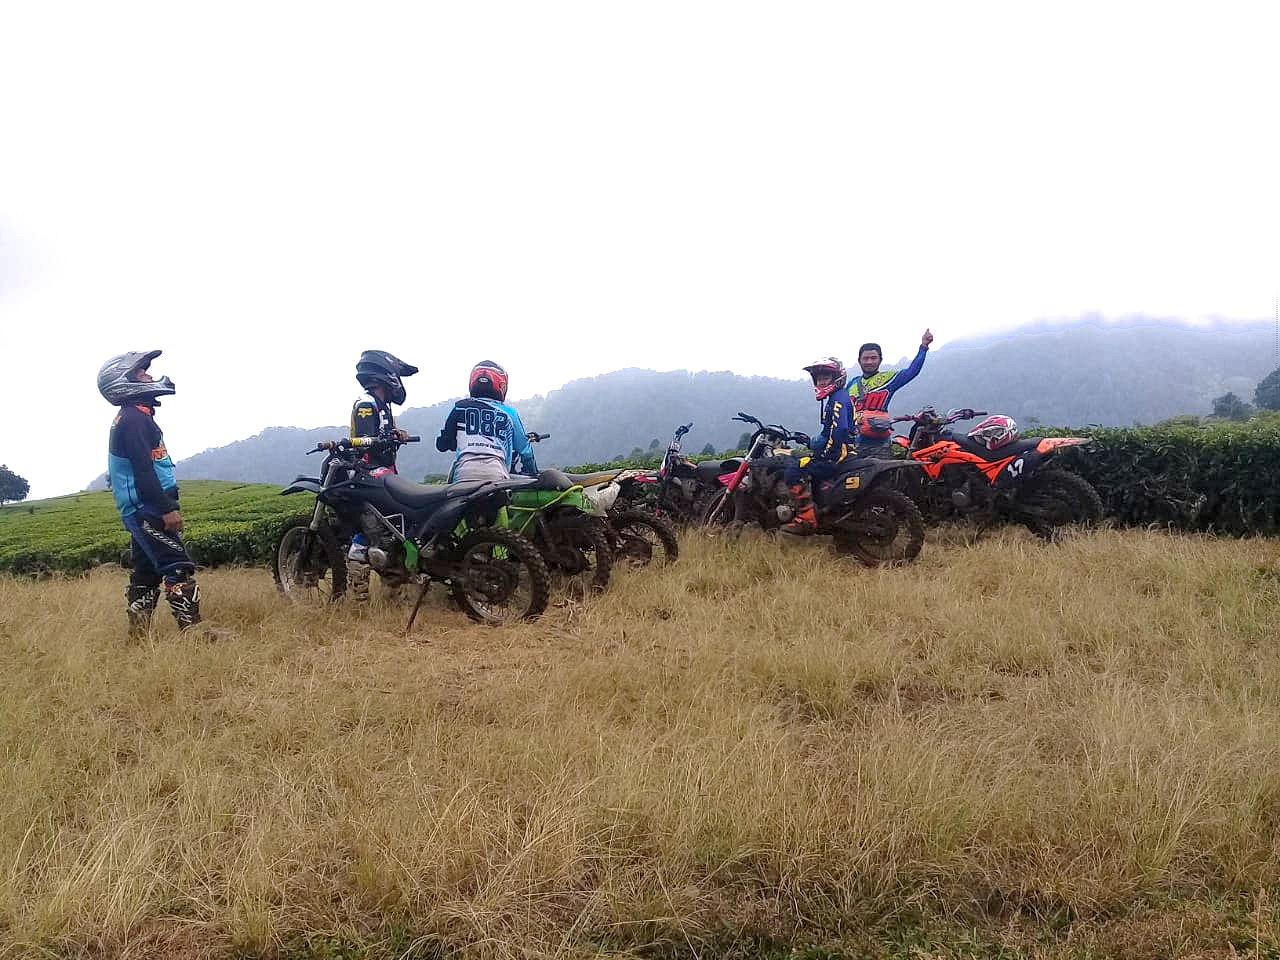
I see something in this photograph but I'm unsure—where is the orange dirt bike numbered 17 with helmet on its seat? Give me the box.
[893,407,1103,540]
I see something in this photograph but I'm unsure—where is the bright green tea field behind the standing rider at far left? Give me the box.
[0,480,312,571]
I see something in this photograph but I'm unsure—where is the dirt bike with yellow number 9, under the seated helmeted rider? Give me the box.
[703,412,924,566]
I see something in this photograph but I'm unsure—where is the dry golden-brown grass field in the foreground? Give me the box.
[0,531,1280,960]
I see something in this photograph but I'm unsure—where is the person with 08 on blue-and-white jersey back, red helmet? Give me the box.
[435,360,538,484]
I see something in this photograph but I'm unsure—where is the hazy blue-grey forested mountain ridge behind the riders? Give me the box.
[85,317,1280,488]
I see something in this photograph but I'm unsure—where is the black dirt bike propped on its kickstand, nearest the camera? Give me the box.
[274,438,550,628]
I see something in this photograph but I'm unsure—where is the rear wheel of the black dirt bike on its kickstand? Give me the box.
[449,527,550,625]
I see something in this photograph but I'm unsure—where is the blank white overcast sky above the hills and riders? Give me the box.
[0,0,1280,498]
